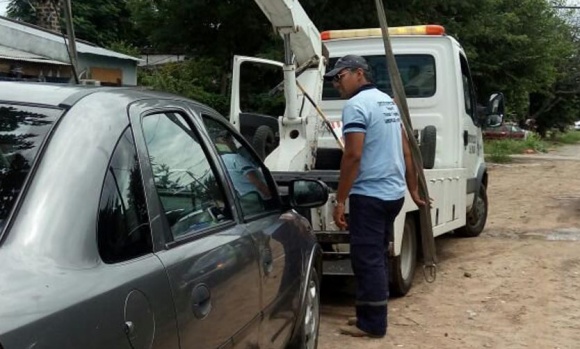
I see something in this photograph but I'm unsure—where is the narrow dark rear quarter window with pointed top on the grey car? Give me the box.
[97,128,152,263]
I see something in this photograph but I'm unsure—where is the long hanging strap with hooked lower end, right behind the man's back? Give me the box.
[375,0,437,281]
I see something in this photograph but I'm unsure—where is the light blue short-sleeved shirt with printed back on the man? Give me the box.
[342,85,407,201]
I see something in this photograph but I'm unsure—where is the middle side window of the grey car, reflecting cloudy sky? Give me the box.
[143,113,232,238]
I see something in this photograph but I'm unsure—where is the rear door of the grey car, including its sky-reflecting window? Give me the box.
[131,102,260,348]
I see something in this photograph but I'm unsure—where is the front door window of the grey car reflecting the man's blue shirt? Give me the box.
[203,116,280,217]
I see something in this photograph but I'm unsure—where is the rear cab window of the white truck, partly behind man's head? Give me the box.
[322,54,436,100]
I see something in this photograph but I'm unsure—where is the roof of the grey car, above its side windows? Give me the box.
[0,81,211,109]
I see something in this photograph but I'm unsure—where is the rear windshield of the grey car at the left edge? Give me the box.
[0,104,62,236]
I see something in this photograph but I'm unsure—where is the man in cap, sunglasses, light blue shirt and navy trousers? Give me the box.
[324,55,425,337]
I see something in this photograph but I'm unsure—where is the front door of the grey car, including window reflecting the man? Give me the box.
[200,110,306,348]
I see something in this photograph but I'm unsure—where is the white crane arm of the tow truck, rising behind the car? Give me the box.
[254,0,328,171]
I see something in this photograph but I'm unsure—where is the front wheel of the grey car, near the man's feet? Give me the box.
[288,268,320,349]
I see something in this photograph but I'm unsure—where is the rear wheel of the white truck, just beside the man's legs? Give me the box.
[389,216,417,297]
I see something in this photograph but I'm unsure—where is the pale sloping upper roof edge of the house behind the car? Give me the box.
[0,16,141,62]
